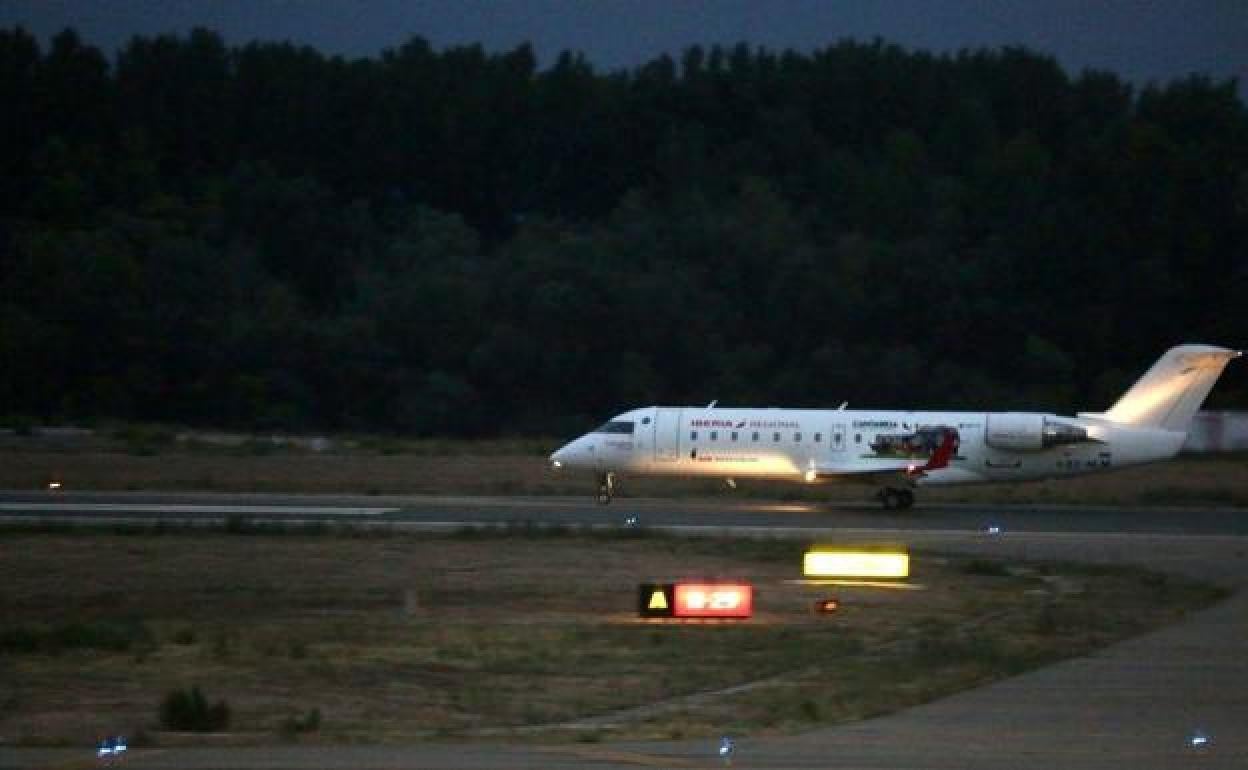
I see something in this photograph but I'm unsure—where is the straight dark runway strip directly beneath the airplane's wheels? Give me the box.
[7,492,1248,537]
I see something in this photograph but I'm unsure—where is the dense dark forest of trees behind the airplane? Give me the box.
[0,29,1248,436]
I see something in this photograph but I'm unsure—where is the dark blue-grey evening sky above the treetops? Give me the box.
[0,0,1248,94]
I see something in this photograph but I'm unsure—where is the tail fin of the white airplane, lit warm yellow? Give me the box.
[1099,344,1242,433]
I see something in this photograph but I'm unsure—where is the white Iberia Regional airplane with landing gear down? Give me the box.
[550,344,1241,508]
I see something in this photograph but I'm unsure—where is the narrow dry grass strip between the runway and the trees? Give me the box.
[0,433,1248,505]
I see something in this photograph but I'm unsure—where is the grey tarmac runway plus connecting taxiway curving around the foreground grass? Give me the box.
[0,492,1248,770]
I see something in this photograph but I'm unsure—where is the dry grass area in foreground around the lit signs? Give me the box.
[0,521,1221,744]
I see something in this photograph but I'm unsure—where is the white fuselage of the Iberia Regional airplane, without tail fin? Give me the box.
[552,407,1187,485]
